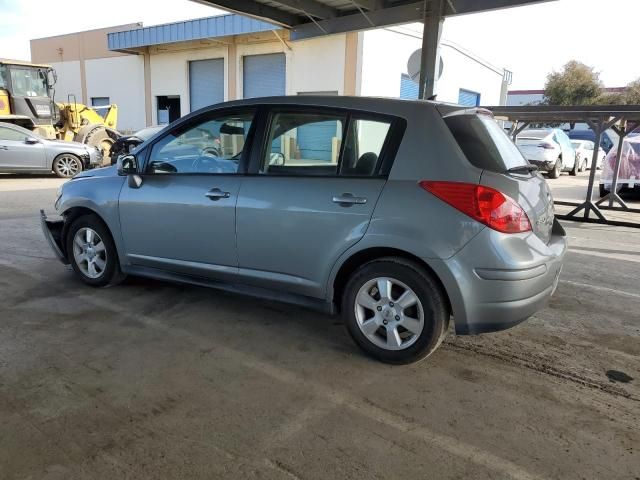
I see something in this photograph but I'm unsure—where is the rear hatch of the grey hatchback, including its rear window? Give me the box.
[444,110,554,243]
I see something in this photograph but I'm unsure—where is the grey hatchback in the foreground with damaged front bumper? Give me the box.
[42,96,567,363]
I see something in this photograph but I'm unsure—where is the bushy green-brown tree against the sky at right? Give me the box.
[544,60,602,105]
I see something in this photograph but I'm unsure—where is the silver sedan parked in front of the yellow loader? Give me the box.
[0,122,102,177]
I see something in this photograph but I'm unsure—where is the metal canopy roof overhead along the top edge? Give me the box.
[193,0,550,40]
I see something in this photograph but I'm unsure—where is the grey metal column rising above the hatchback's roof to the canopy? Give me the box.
[418,0,445,99]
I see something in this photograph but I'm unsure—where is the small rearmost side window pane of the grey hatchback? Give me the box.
[340,119,391,175]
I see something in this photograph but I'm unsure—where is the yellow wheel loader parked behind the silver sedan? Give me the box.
[0,59,120,164]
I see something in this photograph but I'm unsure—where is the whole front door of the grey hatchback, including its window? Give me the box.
[119,110,253,279]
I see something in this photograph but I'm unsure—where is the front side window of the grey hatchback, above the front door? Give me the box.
[147,112,254,174]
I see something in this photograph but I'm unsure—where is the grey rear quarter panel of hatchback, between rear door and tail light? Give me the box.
[359,104,484,258]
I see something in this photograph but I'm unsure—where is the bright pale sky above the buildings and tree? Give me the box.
[0,0,640,89]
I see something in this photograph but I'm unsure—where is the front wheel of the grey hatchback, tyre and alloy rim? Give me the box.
[65,215,125,287]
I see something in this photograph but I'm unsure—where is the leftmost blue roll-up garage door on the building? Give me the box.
[189,58,224,112]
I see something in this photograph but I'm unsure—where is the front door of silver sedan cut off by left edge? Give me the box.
[0,127,46,171]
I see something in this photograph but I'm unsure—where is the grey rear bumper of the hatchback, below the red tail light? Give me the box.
[434,220,567,335]
